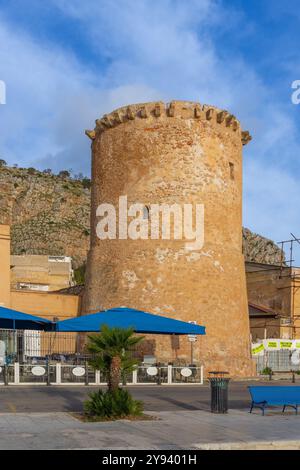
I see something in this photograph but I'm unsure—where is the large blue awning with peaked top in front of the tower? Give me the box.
[55,307,205,335]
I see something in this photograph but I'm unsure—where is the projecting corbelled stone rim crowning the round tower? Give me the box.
[85,101,252,145]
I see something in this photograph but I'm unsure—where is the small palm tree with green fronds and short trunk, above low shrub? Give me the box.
[87,325,144,392]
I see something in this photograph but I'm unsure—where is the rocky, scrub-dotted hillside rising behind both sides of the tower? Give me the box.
[0,166,281,267]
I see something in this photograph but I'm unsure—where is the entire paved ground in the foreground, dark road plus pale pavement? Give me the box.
[0,382,300,450]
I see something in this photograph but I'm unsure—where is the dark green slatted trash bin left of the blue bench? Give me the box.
[209,371,230,414]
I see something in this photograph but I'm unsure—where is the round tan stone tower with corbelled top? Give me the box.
[83,101,252,376]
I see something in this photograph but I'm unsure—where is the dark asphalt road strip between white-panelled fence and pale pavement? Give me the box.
[0,380,291,413]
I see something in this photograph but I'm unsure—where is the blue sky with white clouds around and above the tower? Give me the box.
[0,0,300,258]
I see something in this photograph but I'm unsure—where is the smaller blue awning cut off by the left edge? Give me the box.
[0,307,53,331]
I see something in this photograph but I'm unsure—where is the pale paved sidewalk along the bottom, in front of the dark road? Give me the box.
[0,409,300,450]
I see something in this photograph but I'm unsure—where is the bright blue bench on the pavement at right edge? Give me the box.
[248,385,300,415]
